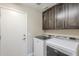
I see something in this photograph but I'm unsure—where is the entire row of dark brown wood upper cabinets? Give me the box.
[43,3,79,30]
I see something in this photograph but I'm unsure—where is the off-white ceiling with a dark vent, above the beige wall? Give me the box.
[23,3,57,11]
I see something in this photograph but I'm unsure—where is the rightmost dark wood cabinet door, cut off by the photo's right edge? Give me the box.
[65,3,79,29]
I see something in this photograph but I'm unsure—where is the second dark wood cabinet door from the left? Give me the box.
[49,7,55,29]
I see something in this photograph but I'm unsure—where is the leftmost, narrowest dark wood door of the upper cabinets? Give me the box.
[43,11,49,30]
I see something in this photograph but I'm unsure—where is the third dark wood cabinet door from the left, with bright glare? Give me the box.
[55,4,64,29]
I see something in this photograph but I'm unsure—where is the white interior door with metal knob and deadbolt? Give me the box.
[1,8,27,56]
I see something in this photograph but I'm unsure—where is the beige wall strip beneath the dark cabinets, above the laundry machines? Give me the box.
[45,29,79,38]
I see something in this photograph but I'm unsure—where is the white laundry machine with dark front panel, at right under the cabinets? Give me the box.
[46,38,79,56]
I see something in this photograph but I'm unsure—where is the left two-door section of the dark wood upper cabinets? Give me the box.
[43,8,55,30]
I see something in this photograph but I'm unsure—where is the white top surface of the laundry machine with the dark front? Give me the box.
[46,38,79,54]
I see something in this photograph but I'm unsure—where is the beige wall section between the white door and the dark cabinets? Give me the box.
[27,5,43,54]
